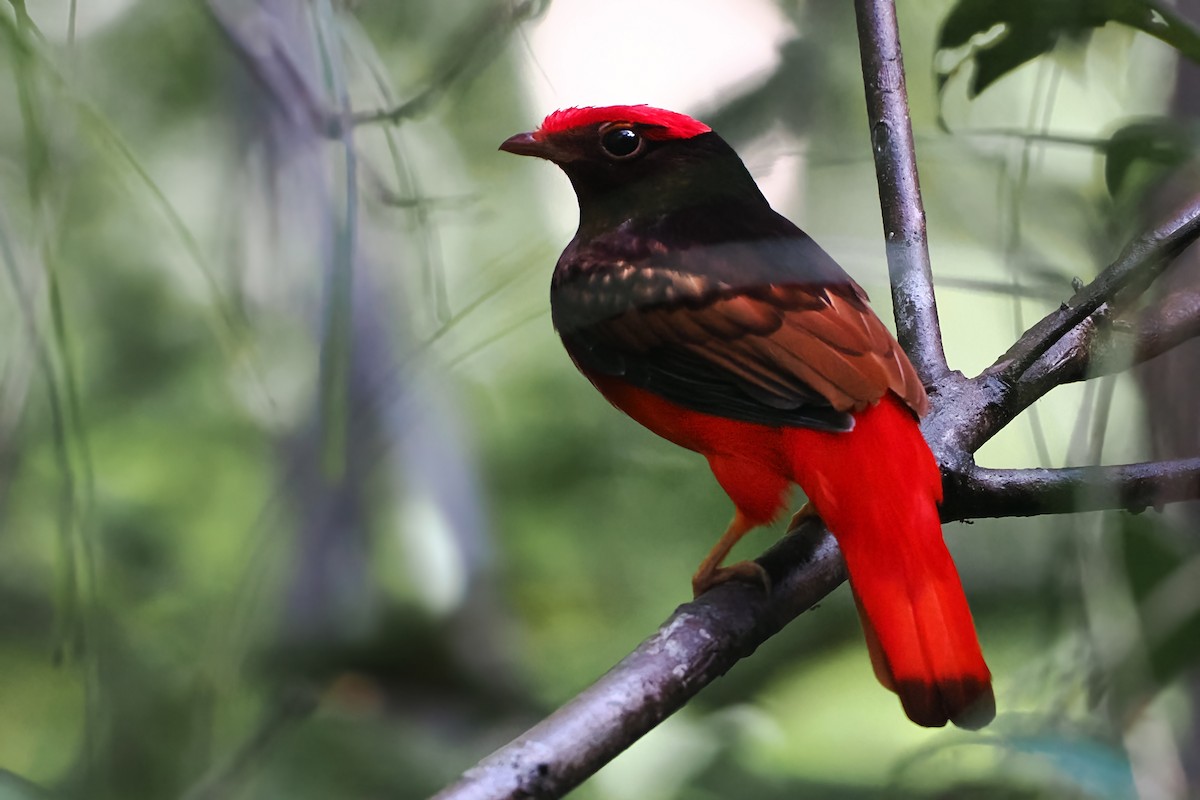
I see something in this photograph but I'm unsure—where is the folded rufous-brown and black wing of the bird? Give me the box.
[560,273,928,431]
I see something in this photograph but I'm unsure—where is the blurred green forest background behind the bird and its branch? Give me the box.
[0,0,1200,800]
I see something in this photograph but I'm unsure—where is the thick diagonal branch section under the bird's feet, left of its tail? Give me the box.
[434,518,846,800]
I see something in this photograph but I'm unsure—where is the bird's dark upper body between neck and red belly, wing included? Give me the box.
[551,219,928,431]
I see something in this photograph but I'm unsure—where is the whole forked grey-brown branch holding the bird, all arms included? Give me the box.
[436,0,1200,800]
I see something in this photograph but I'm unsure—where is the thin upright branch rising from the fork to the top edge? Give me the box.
[854,0,949,386]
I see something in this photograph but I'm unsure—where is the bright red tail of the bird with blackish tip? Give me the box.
[786,395,996,729]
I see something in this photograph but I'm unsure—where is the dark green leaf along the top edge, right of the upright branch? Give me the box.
[937,0,1200,97]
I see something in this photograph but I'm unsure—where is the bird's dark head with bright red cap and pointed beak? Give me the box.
[500,106,762,224]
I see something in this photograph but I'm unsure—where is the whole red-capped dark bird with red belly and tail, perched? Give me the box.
[500,106,995,729]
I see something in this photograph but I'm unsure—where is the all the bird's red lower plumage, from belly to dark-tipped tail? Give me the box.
[588,374,995,729]
